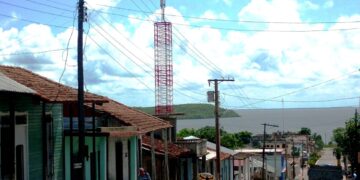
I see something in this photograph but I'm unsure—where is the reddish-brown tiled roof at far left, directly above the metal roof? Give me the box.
[0,66,106,102]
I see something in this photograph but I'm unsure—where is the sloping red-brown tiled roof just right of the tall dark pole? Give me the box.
[96,99,171,133]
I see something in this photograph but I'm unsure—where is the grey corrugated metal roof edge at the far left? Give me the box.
[0,72,36,94]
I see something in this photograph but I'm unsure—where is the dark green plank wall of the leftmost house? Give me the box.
[0,94,63,179]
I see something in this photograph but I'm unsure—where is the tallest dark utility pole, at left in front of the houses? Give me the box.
[77,0,85,180]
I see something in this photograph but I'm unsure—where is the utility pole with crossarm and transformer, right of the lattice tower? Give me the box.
[208,79,234,180]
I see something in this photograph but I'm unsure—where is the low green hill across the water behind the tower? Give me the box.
[134,104,239,119]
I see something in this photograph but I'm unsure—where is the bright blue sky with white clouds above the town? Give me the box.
[0,0,360,109]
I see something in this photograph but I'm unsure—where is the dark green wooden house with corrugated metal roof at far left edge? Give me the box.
[0,72,62,179]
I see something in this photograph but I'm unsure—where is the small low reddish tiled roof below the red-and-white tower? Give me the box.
[142,136,190,157]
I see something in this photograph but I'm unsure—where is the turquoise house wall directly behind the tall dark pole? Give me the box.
[65,136,107,180]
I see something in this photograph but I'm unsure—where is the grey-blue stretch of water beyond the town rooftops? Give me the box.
[177,107,355,142]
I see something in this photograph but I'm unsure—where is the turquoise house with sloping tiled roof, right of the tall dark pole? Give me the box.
[92,99,172,179]
